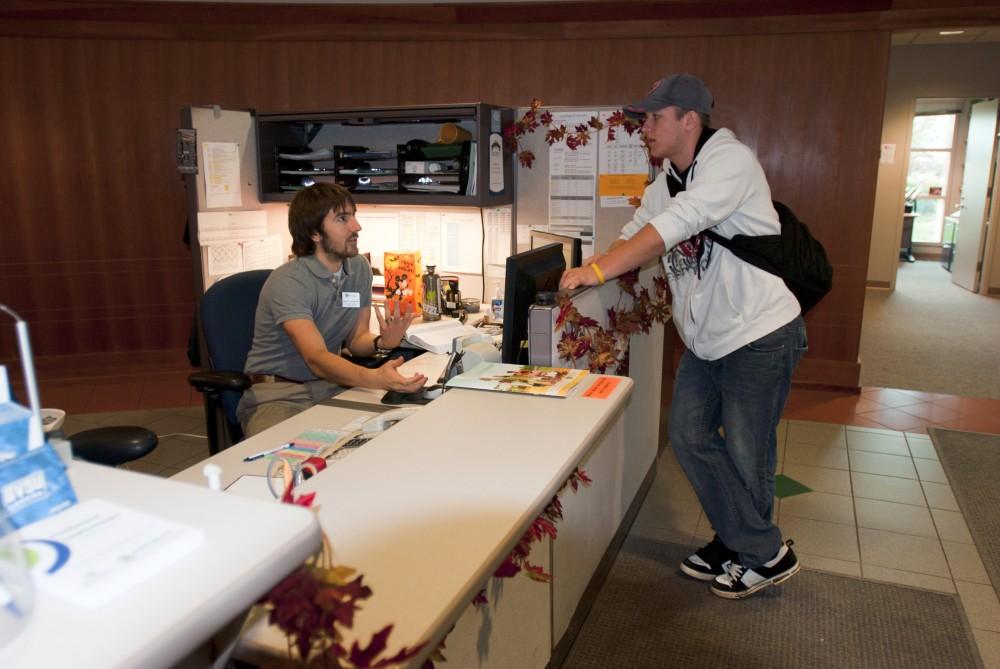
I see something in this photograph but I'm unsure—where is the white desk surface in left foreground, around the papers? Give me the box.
[14,462,321,669]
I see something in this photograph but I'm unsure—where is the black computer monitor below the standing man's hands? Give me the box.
[500,244,566,365]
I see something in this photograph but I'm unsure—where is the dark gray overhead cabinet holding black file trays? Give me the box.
[256,103,514,207]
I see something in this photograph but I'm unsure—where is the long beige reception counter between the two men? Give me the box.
[174,268,662,668]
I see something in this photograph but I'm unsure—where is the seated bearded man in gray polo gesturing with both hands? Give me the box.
[237,183,426,436]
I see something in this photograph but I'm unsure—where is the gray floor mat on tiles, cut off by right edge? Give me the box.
[927,428,1000,589]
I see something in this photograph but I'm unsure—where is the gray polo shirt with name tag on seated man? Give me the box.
[244,255,372,381]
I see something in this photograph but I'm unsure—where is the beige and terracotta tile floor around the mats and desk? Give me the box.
[41,360,1000,669]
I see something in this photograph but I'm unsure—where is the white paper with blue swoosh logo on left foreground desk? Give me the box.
[20,499,204,609]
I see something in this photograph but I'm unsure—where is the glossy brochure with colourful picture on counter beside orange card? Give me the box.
[446,362,587,397]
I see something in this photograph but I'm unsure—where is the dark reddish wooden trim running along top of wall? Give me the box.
[0,0,1000,42]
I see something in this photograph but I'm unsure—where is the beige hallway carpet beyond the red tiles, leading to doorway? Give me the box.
[861,261,1000,398]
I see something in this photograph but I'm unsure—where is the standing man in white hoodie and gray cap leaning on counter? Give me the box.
[560,74,807,599]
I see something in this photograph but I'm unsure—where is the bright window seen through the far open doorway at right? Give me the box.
[906,112,958,244]
